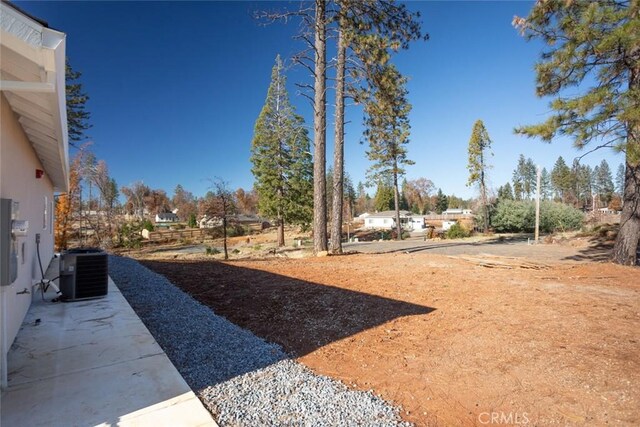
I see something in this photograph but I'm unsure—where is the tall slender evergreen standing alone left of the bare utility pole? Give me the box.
[467,120,493,233]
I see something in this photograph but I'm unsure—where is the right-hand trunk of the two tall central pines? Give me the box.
[331,27,347,254]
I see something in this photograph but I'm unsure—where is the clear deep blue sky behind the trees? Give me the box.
[16,1,623,198]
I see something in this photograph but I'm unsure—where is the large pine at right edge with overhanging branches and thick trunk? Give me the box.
[514,0,640,265]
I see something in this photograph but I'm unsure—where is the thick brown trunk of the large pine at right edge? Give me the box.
[612,162,640,265]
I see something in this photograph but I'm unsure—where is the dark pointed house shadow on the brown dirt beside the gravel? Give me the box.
[141,260,434,357]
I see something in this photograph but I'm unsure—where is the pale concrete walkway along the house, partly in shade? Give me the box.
[0,272,217,427]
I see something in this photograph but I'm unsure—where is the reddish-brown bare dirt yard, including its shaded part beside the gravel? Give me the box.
[131,236,640,425]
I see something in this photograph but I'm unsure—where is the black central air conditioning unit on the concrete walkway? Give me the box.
[60,248,109,301]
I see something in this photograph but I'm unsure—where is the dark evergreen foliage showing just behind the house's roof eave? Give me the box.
[65,59,91,147]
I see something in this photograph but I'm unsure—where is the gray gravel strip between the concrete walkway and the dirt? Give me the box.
[109,256,410,427]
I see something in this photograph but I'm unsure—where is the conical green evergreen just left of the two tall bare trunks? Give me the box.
[251,56,312,246]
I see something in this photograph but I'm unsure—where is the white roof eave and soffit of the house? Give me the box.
[0,2,69,191]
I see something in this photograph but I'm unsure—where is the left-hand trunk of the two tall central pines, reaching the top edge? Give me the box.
[313,0,327,253]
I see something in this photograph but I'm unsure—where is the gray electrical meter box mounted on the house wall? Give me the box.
[0,199,24,286]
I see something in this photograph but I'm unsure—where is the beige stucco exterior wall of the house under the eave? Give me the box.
[0,94,53,368]
